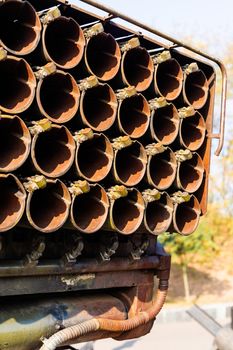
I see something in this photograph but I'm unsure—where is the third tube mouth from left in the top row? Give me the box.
[85,32,121,81]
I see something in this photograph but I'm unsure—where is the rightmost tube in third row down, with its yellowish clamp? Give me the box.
[175,150,204,193]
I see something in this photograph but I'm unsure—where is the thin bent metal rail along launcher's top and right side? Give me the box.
[77,0,227,156]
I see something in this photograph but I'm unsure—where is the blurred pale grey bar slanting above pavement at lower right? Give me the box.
[186,305,221,336]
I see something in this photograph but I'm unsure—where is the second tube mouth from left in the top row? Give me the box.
[42,16,85,69]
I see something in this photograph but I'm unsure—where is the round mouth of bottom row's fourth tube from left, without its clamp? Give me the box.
[110,188,145,235]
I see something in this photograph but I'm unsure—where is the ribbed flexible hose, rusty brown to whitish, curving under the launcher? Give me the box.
[40,280,168,350]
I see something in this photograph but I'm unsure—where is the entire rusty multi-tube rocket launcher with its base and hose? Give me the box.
[0,0,226,350]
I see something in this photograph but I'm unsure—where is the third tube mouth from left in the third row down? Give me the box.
[75,134,113,182]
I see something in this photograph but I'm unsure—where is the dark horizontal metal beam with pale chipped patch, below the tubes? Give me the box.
[0,270,153,296]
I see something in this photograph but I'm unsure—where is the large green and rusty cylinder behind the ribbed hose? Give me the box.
[0,292,126,350]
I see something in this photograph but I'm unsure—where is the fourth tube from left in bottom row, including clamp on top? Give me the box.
[104,185,145,235]
